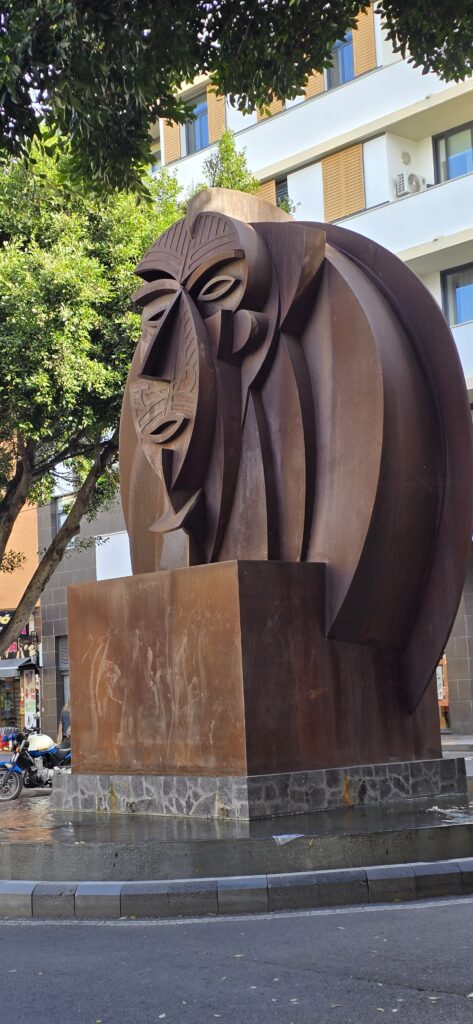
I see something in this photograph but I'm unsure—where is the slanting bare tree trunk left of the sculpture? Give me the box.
[0,431,118,651]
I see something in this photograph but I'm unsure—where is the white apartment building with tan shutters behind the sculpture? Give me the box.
[155,9,473,732]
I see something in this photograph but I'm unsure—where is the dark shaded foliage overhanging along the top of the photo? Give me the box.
[0,0,473,188]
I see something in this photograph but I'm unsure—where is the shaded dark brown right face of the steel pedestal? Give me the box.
[239,562,441,774]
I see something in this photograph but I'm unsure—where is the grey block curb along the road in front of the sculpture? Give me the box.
[0,857,473,921]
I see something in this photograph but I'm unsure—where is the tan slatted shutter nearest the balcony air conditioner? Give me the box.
[321,144,364,220]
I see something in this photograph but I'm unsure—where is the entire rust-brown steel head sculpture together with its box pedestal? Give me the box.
[63,189,473,782]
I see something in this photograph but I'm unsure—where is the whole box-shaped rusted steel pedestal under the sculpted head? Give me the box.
[70,561,440,775]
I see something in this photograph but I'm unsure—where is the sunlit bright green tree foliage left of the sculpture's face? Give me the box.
[0,132,258,649]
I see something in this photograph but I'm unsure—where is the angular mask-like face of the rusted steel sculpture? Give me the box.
[123,206,324,560]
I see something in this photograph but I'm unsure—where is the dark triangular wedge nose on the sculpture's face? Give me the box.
[139,291,181,383]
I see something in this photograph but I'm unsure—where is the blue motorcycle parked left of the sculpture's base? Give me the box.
[0,716,72,801]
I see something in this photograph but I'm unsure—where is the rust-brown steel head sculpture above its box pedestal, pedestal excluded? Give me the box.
[121,189,473,712]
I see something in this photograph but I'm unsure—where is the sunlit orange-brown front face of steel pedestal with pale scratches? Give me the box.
[69,563,246,775]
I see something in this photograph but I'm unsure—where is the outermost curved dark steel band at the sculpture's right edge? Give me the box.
[311,224,473,710]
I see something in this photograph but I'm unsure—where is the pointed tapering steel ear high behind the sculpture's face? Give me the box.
[254,220,326,334]
